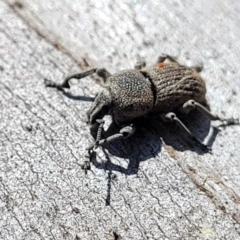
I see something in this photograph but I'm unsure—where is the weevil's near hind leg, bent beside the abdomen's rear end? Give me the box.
[182,99,220,120]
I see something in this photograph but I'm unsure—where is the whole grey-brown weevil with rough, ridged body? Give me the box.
[45,55,232,170]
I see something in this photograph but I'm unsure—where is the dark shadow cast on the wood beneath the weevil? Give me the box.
[88,110,219,175]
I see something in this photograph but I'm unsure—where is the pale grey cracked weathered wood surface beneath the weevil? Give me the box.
[0,0,240,240]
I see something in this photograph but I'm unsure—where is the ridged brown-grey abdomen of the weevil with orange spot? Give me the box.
[143,63,206,112]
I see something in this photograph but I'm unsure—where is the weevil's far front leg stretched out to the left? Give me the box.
[45,68,111,90]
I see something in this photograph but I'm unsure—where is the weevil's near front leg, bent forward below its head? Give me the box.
[87,124,136,151]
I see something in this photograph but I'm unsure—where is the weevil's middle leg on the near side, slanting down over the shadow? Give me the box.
[160,112,210,151]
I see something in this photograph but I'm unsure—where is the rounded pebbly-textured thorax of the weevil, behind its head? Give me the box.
[106,70,154,123]
